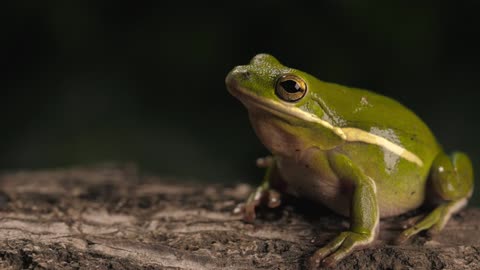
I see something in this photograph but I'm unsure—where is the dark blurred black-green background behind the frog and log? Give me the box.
[0,0,480,204]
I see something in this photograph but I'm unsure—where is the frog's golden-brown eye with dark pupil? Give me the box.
[275,74,307,102]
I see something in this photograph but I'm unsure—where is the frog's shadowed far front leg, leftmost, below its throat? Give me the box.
[233,156,281,222]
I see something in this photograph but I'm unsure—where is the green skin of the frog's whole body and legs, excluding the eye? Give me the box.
[226,54,473,267]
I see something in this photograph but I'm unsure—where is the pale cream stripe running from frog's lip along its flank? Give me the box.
[236,87,423,167]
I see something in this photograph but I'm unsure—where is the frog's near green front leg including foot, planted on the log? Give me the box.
[310,153,379,268]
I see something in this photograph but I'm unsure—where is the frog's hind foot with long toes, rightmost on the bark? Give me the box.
[396,198,467,244]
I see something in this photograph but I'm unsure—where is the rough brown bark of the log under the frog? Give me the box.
[0,163,480,269]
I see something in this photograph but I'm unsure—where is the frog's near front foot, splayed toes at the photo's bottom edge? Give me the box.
[310,231,375,269]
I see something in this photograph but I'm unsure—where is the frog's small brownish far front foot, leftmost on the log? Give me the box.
[233,186,281,222]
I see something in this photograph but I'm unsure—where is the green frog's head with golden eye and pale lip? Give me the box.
[225,54,342,154]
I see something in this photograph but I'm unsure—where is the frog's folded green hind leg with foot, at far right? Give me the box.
[397,152,473,243]
